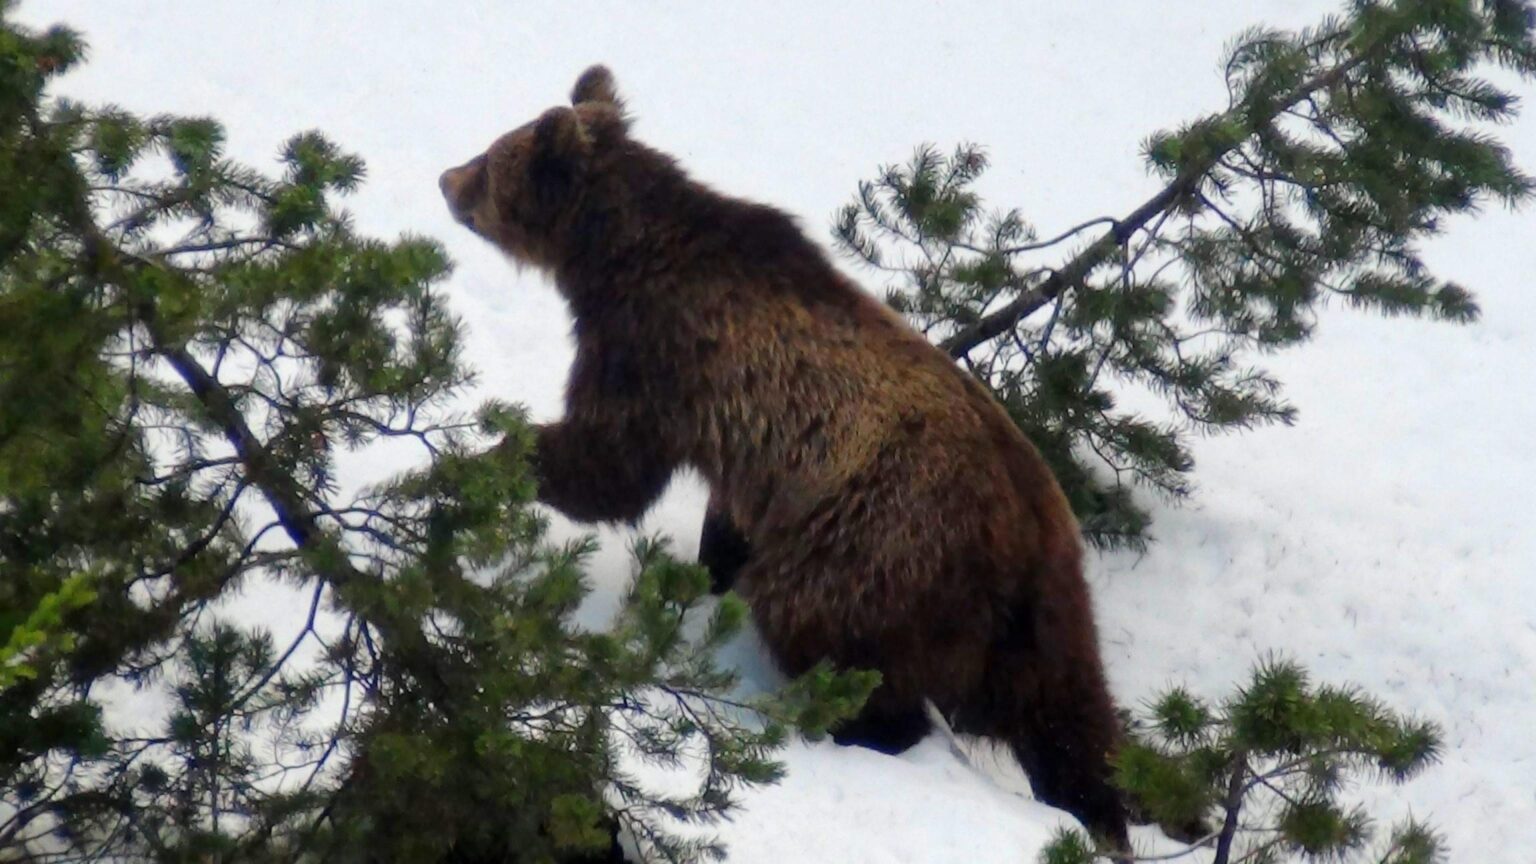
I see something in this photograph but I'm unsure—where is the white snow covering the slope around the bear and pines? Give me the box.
[20,0,1536,864]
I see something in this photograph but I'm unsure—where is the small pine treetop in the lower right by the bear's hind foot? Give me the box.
[1041,658,1445,864]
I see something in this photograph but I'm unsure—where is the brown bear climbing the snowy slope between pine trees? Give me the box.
[441,66,1127,849]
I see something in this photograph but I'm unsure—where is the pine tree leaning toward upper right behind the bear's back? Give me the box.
[834,0,1536,546]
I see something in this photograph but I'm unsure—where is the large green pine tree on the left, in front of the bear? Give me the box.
[0,8,874,861]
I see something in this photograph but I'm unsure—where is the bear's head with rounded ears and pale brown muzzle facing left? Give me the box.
[438,66,628,269]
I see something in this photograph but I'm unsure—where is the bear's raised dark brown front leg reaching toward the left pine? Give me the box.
[531,420,677,523]
